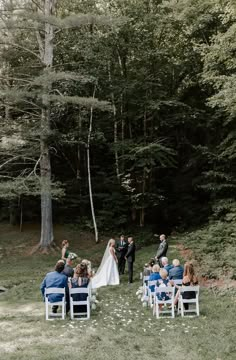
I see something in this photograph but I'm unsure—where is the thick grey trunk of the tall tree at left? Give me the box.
[38,0,56,249]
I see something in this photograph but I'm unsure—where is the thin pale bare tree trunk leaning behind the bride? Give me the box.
[87,86,98,243]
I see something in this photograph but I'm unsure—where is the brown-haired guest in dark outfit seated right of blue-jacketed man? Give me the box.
[70,263,89,313]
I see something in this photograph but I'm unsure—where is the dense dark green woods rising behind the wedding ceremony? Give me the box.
[0,0,236,246]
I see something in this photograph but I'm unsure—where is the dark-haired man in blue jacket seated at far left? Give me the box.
[40,260,70,313]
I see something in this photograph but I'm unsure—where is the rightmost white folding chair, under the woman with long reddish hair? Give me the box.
[179,285,200,317]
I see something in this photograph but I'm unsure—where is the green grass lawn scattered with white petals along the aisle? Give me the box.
[0,226,236,360]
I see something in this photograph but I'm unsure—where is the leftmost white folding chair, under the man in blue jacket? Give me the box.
[44,288,66,320]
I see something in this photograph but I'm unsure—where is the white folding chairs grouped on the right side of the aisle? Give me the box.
[142,276,200,318]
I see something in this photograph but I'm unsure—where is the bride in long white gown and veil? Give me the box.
[92,239,120,289]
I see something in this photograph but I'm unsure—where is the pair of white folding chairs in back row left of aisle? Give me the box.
[44,286,91,320]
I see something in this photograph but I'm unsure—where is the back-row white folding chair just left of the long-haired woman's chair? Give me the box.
[154,286,175,318]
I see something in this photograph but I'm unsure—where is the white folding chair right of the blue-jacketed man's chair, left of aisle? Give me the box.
[69,287,91,320]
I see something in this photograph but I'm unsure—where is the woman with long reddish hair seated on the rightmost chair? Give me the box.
[175,262,198,310]
